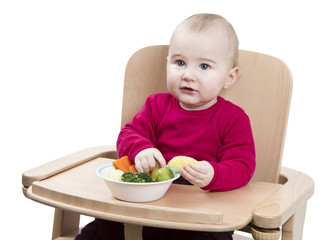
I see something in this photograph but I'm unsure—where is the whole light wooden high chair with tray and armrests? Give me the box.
[22,46,314,240]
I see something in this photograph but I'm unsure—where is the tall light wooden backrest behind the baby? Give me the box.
[121,45,292,183]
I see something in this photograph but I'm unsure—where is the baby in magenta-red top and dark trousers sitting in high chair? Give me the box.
[76,14,255,240]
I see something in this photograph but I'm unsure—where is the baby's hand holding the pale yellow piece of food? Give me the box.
[180,161,215,187]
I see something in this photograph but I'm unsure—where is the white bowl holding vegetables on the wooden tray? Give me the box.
[96,163,180,202]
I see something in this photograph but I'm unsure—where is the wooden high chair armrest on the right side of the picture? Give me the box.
[252,167,314,229]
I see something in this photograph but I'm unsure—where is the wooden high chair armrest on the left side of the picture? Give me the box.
[22,146,118,188]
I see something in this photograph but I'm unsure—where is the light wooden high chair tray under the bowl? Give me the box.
[25,157,281,231]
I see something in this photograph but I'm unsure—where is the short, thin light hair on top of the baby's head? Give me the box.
[174,13,239,67]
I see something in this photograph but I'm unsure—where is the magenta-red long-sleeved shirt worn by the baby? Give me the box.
[117,93,255,191]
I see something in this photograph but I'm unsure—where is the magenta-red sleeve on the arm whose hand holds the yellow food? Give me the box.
[202,111,256,191]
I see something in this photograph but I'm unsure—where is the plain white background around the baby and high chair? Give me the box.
[0,0,327,240]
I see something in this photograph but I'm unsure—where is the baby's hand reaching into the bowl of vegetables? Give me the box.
[134,148,166,172]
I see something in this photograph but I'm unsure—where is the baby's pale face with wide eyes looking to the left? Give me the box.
[167,27,236,110]
